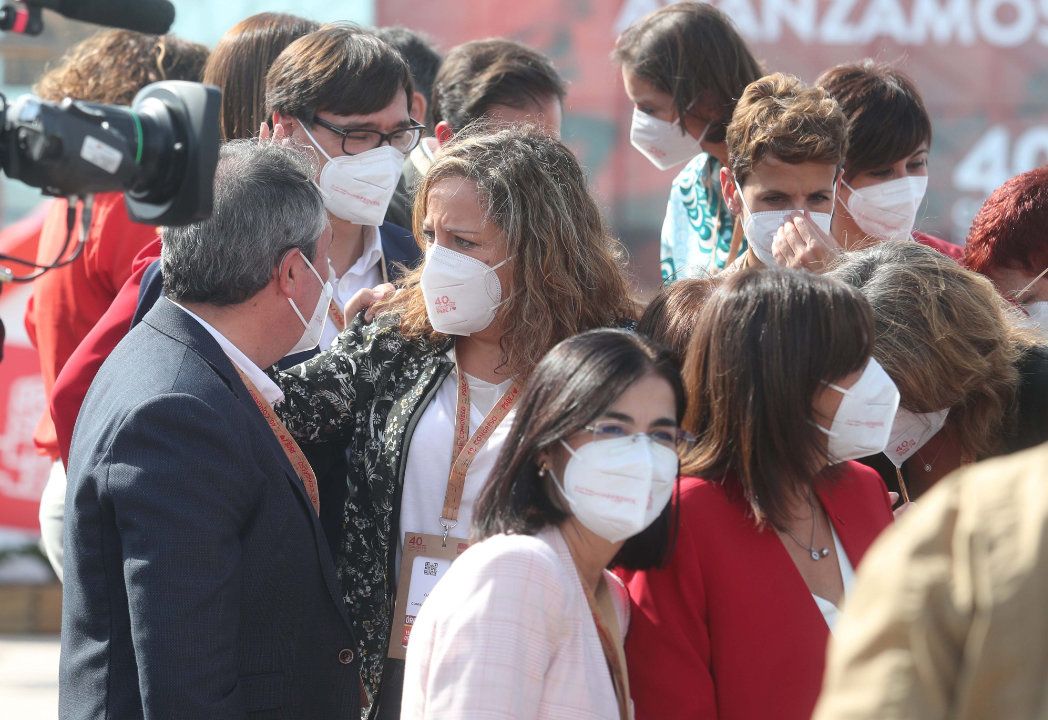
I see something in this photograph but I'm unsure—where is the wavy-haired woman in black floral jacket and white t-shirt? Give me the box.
[278,128,634,717]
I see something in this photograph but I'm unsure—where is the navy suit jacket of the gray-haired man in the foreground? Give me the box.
[60,300,359,720]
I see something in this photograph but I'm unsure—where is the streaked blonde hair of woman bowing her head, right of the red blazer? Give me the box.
[830,240,1032,459]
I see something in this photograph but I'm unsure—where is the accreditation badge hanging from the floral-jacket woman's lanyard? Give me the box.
[389,532,470,660]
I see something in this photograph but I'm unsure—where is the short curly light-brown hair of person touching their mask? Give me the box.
[725,72,848,184]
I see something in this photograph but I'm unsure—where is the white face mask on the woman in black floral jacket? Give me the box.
[419,243,509,335]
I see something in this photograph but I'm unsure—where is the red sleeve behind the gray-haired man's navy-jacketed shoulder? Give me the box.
[50,238,160,464]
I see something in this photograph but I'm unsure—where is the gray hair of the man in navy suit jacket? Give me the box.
[160,139,328,305]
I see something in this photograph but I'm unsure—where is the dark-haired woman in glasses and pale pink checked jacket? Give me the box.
[402,330,687,720]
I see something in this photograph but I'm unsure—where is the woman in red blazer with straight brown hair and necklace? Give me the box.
[627,268,899,720]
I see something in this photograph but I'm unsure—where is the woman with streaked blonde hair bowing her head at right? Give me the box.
[829,241,1048,498]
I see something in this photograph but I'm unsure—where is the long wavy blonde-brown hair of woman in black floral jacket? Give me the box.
[376,127,637,379]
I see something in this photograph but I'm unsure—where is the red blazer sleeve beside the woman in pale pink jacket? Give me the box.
[626,477,717,720]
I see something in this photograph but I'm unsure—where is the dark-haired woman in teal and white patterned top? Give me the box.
[612,2,764,283]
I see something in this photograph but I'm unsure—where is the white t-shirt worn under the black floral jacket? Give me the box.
[394,352,517,568]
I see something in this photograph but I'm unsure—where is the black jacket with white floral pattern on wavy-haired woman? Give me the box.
[275,314,454,697]
